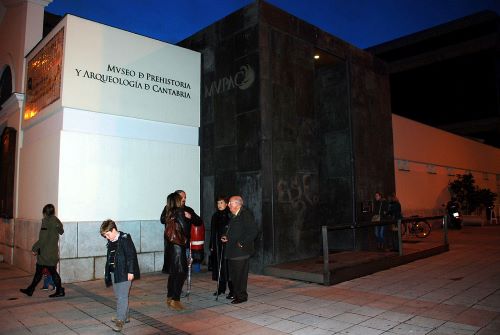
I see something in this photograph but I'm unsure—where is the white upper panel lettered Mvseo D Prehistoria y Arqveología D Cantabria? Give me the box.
[62,15,201,127]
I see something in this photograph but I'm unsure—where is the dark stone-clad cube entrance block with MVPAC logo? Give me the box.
[179,1,395,272]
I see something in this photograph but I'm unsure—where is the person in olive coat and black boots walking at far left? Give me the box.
[20,204,65,298]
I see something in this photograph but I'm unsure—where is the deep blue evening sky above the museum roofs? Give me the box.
[47,0,500,48]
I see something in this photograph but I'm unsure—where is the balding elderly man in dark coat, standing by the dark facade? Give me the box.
[221,195,259,304]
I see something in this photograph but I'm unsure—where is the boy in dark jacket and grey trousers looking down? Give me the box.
[101,219,141,332]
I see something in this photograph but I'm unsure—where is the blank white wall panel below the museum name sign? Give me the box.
[59,131,200,221]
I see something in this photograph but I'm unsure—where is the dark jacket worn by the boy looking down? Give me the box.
[104,231,141,286]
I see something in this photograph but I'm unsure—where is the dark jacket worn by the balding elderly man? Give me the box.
[226,207,259,259]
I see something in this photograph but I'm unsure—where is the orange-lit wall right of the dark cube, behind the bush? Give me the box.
[392,114,500,216]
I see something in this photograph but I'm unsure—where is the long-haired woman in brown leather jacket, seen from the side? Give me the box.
[165,193,188,311]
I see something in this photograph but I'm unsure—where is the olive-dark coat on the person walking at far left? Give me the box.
[31,215,64,266]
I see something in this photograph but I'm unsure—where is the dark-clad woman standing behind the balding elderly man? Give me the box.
[209,196,234,299]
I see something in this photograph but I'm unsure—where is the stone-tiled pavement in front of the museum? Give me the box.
[0,226,500,335]
